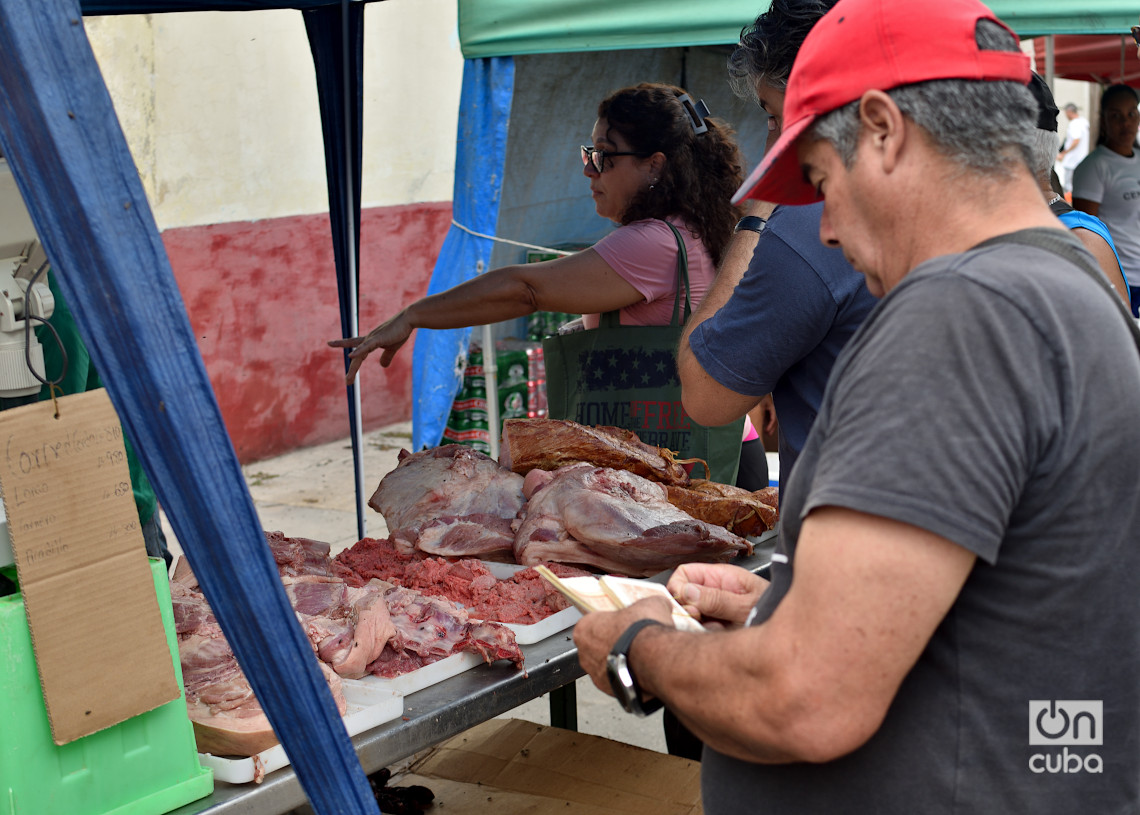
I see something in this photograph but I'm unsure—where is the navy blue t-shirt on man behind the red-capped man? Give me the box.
[689,203,878,488]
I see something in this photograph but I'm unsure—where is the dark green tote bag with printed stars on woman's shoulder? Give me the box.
[543,221,744,484]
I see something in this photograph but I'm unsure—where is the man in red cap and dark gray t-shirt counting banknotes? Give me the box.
[575,0,1140,815]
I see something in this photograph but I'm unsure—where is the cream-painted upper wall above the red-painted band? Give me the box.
[84,0,463,229]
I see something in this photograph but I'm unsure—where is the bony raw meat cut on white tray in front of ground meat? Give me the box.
[368,586,522,677]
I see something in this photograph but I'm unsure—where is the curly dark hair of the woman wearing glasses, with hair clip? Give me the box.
[597,82,744,264]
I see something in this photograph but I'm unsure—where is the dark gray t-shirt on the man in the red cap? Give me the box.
[702,230,1140,815]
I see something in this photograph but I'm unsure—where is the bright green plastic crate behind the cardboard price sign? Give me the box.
[0,559,213,815]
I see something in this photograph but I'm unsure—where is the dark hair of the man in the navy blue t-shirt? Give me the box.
[728,0,839,100]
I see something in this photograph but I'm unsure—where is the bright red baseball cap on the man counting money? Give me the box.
[732,0,1031,204]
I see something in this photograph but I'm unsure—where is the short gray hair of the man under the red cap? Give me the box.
[811,21,1037,176]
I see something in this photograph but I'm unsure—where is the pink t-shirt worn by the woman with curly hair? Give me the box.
[583,218,716,328]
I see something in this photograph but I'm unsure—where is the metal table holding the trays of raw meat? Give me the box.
[170,537,775,815]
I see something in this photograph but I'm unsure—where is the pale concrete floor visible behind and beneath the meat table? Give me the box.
[163,423,666,752]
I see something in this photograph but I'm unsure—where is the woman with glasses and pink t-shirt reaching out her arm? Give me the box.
[328,83,752,469]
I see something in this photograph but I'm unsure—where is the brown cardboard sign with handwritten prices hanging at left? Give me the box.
[0,390,180,744]
